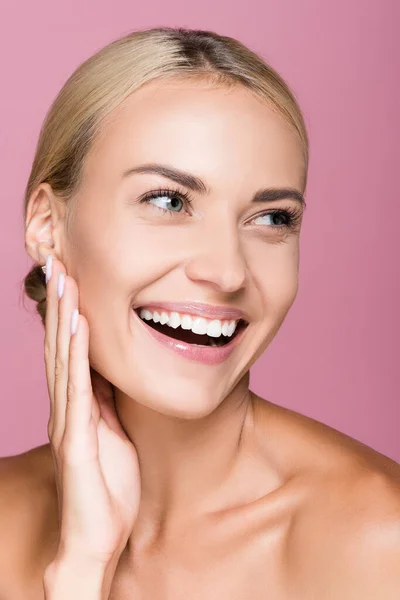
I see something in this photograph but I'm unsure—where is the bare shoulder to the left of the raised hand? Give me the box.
[0,445,58,600]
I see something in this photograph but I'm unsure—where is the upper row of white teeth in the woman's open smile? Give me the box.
[139,308,242,338]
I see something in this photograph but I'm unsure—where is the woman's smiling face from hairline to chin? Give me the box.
[61,79,304,418]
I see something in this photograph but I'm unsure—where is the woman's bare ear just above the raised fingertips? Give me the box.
[25,183,66,265]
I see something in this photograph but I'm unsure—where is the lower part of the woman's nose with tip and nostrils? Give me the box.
[185,225,248,293]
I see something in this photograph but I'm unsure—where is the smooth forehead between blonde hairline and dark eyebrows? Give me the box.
[89,79,303,188]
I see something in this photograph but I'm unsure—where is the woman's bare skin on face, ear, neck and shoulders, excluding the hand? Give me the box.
[0,80,400,600]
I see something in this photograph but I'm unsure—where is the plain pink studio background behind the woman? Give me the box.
[0,0,400,462]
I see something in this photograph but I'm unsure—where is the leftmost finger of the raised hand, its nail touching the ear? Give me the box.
[44,258,63,436]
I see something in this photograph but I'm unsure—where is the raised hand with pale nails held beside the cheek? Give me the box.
[45,258,140,565]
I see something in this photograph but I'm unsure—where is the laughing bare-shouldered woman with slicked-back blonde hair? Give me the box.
[0,28,400,600]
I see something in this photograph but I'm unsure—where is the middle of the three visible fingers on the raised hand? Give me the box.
[53,272,78,444]
